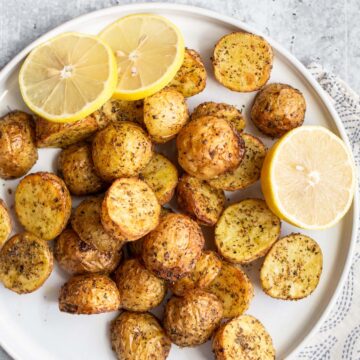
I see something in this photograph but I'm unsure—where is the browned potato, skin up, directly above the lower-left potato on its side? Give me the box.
[54,228,122,274]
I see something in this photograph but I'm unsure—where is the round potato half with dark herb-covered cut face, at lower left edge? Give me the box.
[0,232,53,294]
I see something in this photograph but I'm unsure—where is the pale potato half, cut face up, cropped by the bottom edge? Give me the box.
[212,315,275,360]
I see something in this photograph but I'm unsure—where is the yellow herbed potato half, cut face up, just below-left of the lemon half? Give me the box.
[215,199,281,264]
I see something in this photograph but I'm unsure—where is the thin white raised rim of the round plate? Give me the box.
[0,2,359,360]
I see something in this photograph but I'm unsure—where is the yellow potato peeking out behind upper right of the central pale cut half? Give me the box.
[140,154,179,205]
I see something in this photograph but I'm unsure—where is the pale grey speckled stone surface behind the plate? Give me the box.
[0,0,360,360]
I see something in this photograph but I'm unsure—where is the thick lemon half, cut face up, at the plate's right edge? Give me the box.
[261,126,356,229]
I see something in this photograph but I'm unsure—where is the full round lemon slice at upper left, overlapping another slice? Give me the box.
[19,33,117,122]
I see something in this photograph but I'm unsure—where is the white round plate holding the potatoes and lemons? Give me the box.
[0,4,358,360]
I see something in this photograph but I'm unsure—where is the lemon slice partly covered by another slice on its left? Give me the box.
[100,14,185,100]
